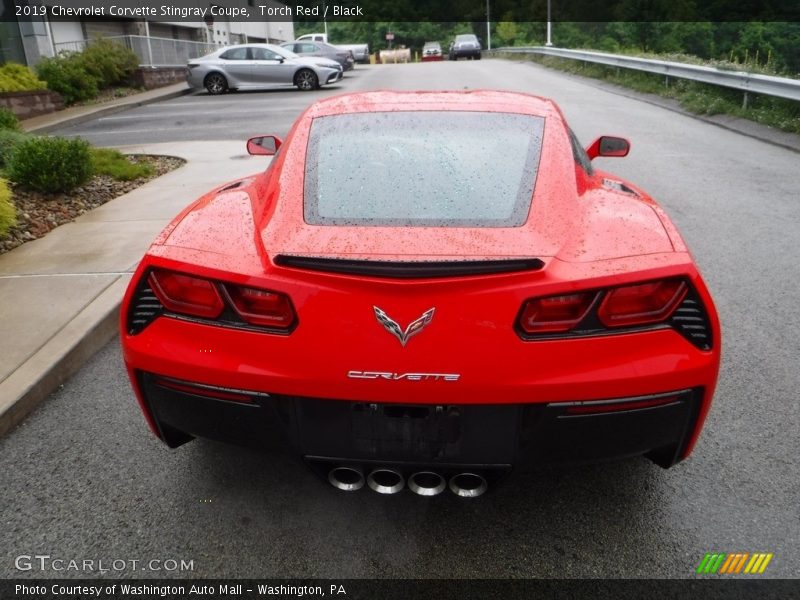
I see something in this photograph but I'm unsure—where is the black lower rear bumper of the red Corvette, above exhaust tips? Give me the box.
[133,372,707,471]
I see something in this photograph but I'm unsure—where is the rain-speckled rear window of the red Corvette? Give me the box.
[304,111,544,227]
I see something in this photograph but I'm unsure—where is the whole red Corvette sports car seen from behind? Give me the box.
[121,91,720,496]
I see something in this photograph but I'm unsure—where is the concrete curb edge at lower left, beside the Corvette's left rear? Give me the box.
[0,275,131,437]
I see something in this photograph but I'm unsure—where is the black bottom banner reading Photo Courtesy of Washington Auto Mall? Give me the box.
[0,576,800,600]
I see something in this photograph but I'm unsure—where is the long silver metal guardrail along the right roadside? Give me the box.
[493,46,800,106]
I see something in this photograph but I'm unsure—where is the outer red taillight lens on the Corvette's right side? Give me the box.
[597,279,688,327]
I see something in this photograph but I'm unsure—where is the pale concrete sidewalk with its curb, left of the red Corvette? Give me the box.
[0,141,269,435]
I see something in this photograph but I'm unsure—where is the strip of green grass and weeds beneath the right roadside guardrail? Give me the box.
[508,55,800,134]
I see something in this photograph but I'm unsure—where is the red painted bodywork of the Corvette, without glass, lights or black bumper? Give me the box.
[122,91,721,482]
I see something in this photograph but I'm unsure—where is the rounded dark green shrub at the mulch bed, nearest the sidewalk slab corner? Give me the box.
[7,137,92,193]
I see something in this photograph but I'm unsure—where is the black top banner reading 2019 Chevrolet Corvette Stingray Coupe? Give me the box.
[0,0,800,23]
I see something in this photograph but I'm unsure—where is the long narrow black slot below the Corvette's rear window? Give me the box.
[275,254,544,279]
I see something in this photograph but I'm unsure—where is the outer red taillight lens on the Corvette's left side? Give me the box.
[148,270,225,319]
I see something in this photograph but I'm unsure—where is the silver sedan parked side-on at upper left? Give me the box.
[186,44,343,94]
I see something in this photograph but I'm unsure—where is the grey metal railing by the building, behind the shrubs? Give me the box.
[55,35,218,67]
